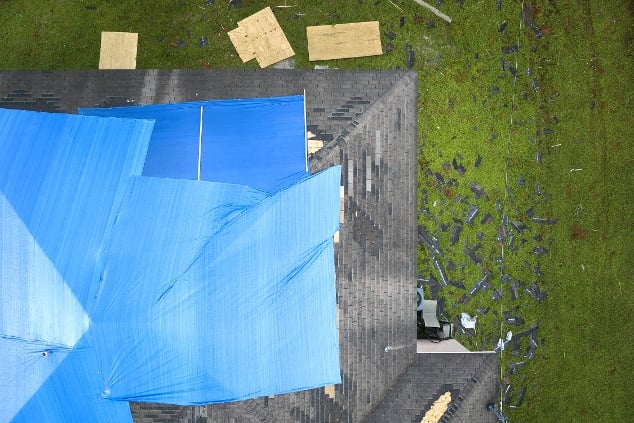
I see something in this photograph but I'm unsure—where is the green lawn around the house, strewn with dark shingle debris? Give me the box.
[0,0,634,422]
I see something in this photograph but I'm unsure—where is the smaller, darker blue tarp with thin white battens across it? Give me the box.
[79,95,308,191]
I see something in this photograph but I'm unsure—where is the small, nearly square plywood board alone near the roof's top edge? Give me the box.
[99,32,139,69]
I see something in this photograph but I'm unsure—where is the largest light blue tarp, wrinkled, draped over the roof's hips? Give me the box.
[0,100,340,422]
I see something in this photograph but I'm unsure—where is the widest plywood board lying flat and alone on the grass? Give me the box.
[306,21,383,61]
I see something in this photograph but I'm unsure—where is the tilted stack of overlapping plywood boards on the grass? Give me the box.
[229,7,295,68]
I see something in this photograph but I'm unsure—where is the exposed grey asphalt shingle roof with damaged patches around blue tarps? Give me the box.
[0,69,497,423]
